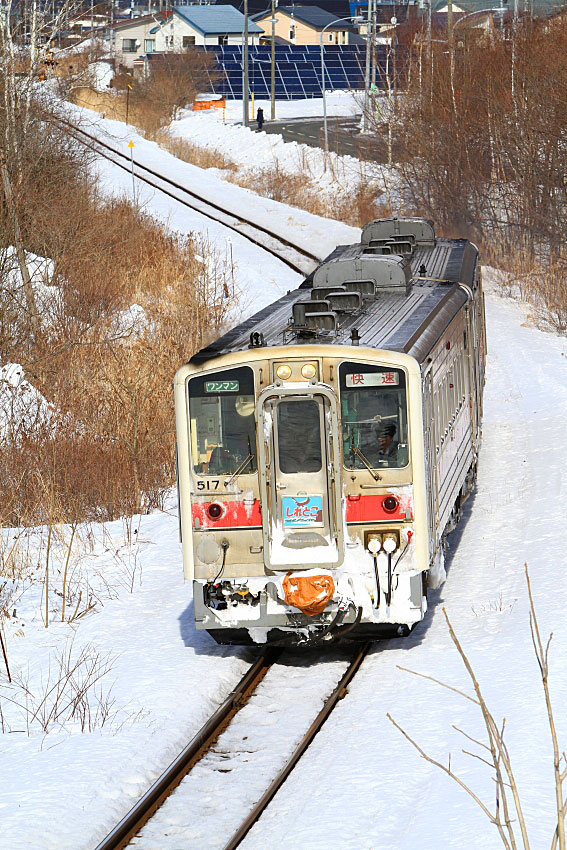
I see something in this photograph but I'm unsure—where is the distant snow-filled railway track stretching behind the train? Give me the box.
[58,119,322,275]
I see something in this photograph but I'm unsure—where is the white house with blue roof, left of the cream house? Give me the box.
[112,5,262,68]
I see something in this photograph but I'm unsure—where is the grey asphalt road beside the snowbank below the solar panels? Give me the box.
[252,115,383,161]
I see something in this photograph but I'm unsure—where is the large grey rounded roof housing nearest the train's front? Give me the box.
[311,252,411,298]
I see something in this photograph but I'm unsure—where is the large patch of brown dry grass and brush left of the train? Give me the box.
[0,129,235,525]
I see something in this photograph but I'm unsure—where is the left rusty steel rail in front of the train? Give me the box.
[95,648,281,850]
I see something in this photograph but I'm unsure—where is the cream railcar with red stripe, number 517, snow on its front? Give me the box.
[174,217,486,647]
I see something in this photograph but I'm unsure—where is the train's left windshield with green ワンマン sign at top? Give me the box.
[189,366,258,475]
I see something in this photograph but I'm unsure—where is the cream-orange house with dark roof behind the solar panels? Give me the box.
[254,6,353,44]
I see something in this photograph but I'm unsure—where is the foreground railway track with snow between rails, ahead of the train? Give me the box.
[96,644,369,850]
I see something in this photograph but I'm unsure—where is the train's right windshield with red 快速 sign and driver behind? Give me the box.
[340,363,409,469]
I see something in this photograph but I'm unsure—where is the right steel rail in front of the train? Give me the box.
[223,643,371,850]
